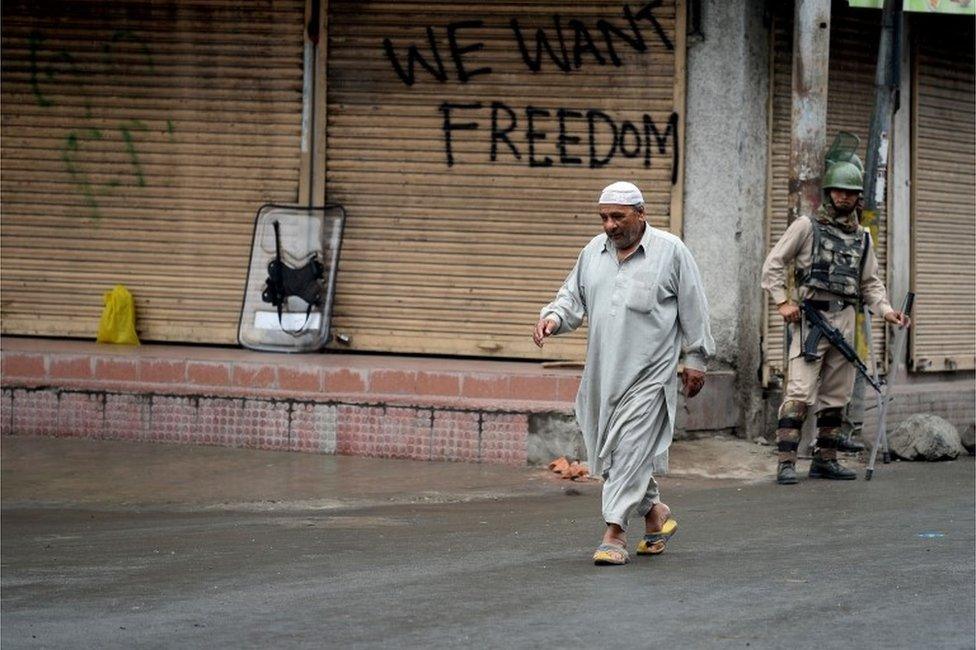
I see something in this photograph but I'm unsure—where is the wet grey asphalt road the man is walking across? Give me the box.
[0,437,976,650]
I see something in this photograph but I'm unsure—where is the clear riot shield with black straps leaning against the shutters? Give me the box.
[237,204,346,352]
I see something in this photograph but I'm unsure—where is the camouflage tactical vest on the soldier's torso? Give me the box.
[796,219,869,301]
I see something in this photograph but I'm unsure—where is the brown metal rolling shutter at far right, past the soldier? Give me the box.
[911,16,976,371]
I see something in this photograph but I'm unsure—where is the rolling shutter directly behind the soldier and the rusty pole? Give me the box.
[763,2,888,378]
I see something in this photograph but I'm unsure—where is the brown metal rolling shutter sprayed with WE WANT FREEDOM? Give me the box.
[326,1,684,358]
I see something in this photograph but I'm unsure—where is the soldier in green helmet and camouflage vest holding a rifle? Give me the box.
[762,161,909,485]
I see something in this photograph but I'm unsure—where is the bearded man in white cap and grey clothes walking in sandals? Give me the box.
[533,182,715,564]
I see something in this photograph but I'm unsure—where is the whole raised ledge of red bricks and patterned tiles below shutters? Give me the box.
[0,338,580,465]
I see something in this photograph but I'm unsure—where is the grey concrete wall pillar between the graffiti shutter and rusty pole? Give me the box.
[683,0,769,436]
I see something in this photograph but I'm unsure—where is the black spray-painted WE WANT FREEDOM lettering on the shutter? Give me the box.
[382,0,678,182]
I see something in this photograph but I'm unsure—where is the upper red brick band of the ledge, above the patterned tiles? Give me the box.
[0,338,580,411]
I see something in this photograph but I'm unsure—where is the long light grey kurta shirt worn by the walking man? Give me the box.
[541,226,715,475]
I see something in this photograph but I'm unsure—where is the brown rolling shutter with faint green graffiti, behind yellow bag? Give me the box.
[0,0,305,343]
